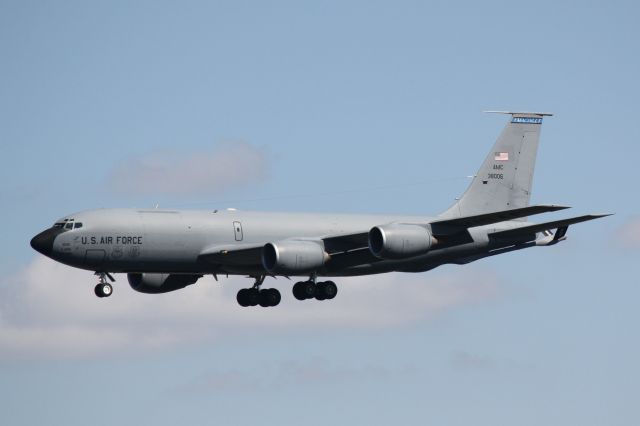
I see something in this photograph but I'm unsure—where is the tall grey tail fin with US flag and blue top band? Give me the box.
[441,111,552,218]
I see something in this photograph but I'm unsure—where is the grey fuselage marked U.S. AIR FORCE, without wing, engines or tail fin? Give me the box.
[38,209,510,276]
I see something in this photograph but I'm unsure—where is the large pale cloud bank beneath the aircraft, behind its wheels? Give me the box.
[0,257,499,358]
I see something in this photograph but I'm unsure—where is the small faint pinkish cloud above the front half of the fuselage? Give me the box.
[109,142,268,195]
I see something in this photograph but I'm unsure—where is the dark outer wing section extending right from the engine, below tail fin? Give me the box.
[431,204,569,235]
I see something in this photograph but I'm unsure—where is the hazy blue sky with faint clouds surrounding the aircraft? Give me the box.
[0,1,640,425]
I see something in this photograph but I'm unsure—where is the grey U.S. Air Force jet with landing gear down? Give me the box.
[31,111,607,307]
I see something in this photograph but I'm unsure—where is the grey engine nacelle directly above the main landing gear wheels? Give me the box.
[262,241,329,274]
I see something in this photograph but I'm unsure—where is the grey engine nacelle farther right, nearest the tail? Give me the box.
[369,224,436,259]
